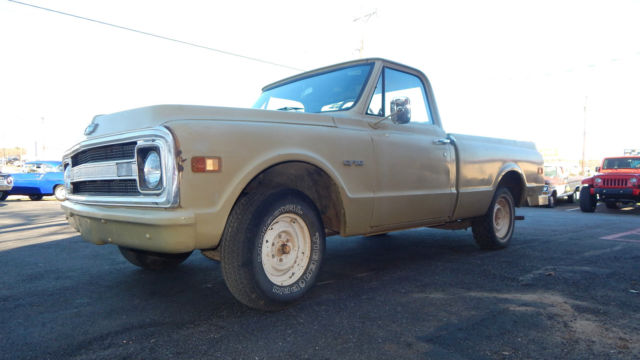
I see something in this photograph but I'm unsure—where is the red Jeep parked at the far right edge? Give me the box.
[580,156,640,212]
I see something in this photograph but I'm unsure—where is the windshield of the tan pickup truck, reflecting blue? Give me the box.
[253,64,373,113]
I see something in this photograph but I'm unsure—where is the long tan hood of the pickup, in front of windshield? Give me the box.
[85,105,336,139]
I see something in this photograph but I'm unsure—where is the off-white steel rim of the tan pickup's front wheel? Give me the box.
[261,213,311,286]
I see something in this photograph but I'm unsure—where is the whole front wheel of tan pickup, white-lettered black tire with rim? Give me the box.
[220,189,325,311]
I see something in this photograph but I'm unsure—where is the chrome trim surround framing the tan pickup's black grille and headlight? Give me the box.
[63,127,180,208]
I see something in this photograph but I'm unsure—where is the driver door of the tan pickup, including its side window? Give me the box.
[367,68,456,227]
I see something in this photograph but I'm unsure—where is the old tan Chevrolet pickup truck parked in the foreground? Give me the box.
[62,59,546,310]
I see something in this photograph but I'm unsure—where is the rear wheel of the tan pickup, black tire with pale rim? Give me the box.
[471,187,515,250]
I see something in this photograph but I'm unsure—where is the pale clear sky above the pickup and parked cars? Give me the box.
[0,0,640,163]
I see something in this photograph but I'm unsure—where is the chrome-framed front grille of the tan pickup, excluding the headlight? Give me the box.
[64,127,179,207]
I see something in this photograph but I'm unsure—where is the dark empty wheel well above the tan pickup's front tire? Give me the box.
[242,161,344,235]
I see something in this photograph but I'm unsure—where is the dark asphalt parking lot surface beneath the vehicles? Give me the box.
[0,198,640,359]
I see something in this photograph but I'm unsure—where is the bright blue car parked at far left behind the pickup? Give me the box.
[0,161,67,201]
